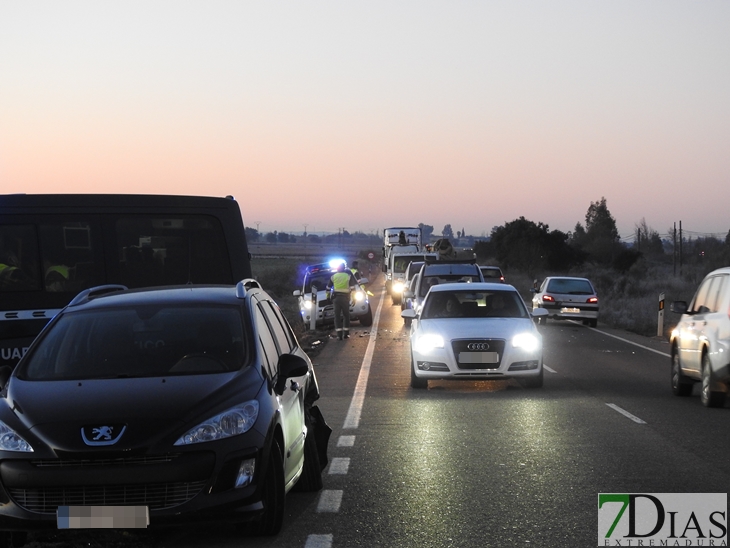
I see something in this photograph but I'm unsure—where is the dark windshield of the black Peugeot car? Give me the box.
[18,306,248,380]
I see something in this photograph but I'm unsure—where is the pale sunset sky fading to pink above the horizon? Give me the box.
[0,0,730,240]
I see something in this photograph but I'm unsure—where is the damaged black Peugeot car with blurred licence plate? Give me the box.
[0,280,330,543]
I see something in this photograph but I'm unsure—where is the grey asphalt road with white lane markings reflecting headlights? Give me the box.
[24,287,730,548]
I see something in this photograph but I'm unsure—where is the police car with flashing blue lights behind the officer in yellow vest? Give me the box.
[293,259,373,327]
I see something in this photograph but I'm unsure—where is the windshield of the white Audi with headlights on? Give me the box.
[421,290,529,319]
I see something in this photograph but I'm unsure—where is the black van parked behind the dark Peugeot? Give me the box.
[0,194,251,366]
